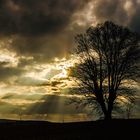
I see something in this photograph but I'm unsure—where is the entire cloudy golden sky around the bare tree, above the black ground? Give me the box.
[0,0,140,121]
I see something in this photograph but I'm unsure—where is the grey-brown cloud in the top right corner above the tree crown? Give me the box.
[92,0,140,32]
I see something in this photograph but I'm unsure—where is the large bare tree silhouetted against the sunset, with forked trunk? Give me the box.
[70,21,140,119]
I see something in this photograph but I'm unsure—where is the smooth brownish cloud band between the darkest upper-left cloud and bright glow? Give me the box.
[7,32,74,64]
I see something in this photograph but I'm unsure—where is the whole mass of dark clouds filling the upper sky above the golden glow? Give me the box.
[0,0,140,82]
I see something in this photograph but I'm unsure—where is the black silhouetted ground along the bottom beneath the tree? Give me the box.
[0,120,140,140]
